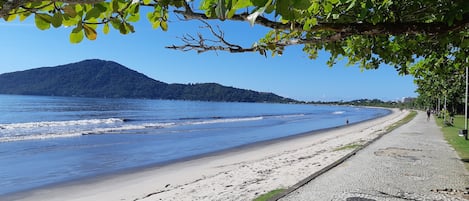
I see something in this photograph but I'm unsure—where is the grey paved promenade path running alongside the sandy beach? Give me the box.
[281,112,469,201]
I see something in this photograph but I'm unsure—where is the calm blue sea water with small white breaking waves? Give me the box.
[0,95,389,195]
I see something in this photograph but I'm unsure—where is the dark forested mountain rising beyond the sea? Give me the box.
[0,59,294,103]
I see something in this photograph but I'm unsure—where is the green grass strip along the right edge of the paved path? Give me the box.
[436,115,469,170]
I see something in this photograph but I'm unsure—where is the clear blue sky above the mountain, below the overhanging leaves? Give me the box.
[0,8,417,101]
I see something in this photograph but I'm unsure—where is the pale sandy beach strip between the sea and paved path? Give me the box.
[11,109,408,201]
